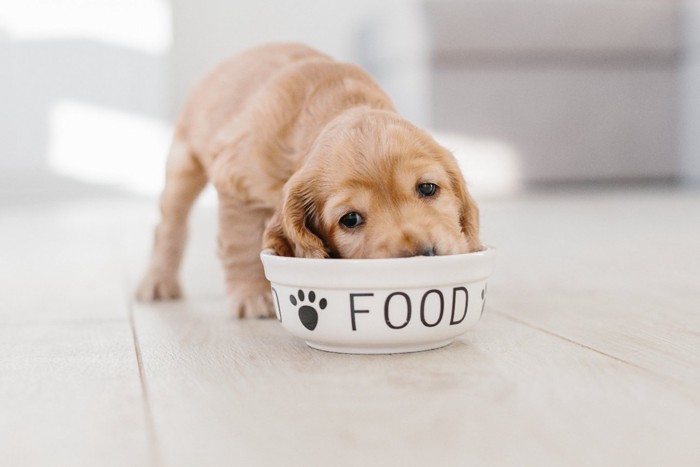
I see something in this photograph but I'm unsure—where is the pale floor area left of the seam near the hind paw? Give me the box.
[0,187,157,467]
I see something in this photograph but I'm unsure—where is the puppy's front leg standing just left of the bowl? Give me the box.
[219,194,274,318]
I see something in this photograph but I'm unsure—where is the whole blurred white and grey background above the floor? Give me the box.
[0,0,700,196]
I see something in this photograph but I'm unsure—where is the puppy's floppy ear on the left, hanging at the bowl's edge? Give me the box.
[263,175,329,258]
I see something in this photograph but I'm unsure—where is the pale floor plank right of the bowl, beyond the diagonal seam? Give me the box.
[483,190,700,391]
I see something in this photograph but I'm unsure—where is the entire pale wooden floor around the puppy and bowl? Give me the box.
[0,174,700,467]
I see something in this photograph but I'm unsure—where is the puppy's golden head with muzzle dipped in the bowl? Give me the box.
[264,110,481,258]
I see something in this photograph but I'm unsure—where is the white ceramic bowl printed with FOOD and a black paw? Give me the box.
[260,248,495,354]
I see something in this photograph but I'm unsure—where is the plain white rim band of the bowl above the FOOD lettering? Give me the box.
[260,245,496,289]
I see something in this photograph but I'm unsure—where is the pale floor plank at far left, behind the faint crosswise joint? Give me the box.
[0,199,138,324]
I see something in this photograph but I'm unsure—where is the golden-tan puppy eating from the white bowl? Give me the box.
[137,44,481,317]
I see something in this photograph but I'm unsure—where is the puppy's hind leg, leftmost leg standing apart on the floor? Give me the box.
[136,140,207,301]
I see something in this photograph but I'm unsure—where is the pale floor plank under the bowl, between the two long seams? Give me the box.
[135,301,700,466]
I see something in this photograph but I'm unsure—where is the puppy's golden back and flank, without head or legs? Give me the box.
[175,44,394,205]
